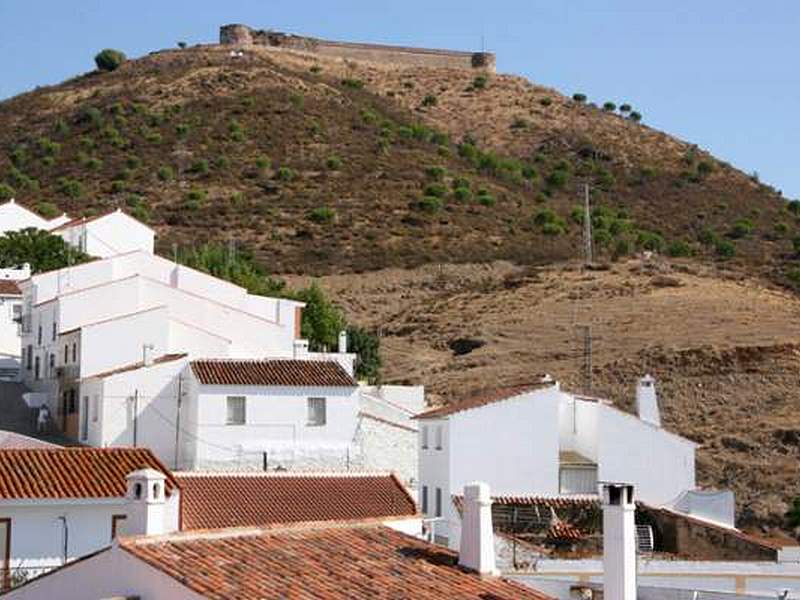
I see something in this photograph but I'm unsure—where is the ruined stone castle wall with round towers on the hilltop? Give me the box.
[219,24,495,73]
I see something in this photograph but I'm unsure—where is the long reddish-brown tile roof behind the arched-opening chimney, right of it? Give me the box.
[175,472,417,529]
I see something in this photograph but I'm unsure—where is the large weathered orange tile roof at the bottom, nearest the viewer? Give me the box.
[120,523,548,600]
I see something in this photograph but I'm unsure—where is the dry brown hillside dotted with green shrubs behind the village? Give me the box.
[0,39,800,527]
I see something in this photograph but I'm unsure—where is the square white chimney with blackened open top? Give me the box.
[603,483,636,600]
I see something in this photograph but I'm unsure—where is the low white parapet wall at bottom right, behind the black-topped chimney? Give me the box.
[510,558,800,598]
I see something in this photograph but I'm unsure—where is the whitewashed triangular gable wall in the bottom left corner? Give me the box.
[5,546,205,600]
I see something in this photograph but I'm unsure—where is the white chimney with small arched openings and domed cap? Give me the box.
[125,469,167,535]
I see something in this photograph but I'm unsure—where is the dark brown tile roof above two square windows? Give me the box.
[192,359,357,387]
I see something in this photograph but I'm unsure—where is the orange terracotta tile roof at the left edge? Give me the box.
[0,448,175,500]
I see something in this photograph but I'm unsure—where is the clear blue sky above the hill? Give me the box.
[0,0,800,198]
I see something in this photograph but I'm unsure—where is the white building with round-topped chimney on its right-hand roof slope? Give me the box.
[417,379,695,547]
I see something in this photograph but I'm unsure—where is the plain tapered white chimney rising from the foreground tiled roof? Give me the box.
[458,482,498,575]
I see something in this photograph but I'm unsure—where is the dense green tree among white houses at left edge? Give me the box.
[0,227,90,273]
